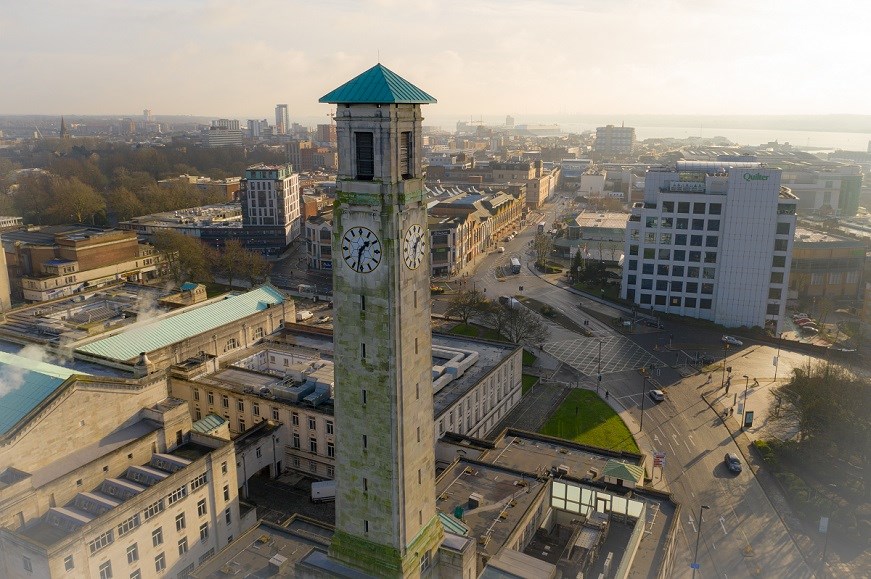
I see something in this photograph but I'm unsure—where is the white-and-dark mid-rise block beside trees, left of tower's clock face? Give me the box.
[241,164,300,254]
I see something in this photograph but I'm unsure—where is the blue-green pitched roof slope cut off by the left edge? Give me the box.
[0,352,84,434]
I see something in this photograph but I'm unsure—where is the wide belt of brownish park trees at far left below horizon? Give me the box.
[0,139,286,226]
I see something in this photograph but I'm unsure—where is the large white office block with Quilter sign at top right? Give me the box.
[621,161,798,332]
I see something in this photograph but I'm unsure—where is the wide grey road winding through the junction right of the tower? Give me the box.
[450,196,812,578]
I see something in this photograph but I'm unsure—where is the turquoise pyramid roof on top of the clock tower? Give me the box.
[318,64,437,105]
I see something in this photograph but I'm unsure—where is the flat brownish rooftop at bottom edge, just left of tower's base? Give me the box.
[190,516,333,579]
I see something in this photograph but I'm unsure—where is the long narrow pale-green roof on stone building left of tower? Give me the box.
[77,286,284,360]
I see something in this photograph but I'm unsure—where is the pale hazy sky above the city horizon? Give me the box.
[0,0,871,122]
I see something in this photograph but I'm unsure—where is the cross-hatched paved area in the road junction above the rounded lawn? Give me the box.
[544,336,665,376]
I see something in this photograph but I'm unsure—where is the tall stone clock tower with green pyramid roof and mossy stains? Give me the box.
[320,64,443,577]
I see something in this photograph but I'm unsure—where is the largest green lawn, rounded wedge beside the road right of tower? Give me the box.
[539,390,640,452]
